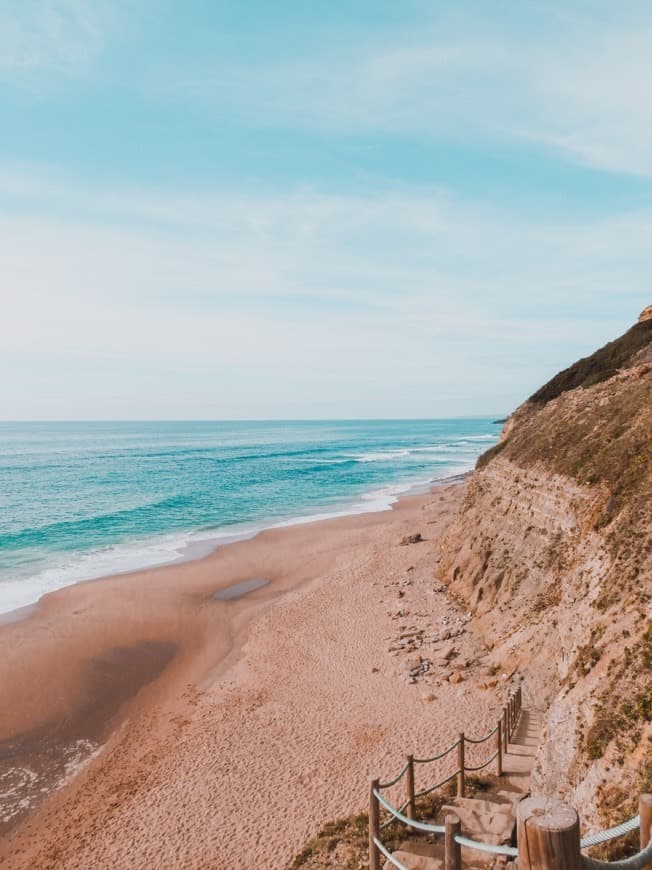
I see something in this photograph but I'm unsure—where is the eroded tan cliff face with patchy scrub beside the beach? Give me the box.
[437,321,652,825]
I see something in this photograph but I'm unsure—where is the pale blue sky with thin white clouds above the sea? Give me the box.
[0,0,652,420]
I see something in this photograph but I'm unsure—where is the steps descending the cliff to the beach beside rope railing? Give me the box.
[384,708,542,870]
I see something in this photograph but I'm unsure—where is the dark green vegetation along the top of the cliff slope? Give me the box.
[530,320,652,404]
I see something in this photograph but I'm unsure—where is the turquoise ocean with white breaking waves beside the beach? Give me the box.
[0,418,499,613]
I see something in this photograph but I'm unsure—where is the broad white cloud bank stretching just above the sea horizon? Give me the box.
[0,169,652,417]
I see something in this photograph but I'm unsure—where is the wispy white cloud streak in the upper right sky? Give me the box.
[162,8,652,176]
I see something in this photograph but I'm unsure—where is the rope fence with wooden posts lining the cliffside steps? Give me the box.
[369,686,652,870]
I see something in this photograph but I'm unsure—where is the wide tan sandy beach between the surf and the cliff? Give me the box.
[0,484,501,870]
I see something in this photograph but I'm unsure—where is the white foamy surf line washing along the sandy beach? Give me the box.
[0,469,472,630]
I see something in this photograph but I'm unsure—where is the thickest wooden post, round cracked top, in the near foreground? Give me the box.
[517,796,582,870]
